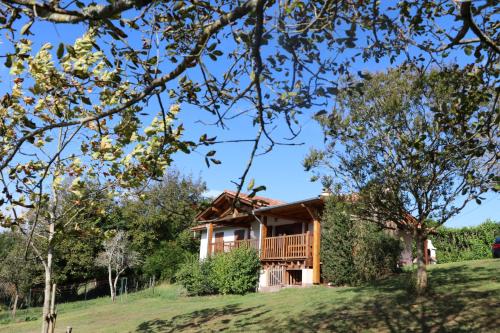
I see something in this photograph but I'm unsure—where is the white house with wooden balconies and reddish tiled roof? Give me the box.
[191,191,418,290]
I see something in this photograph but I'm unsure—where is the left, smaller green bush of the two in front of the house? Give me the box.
[175,255,215,295]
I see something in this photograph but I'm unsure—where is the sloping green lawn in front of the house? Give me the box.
[0,259,500,333]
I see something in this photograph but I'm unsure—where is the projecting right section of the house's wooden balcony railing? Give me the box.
[260,233,313,260]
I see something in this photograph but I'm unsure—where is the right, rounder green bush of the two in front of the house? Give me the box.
[210,247,260,294]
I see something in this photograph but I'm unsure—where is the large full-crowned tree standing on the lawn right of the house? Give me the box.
[305,67,500,292]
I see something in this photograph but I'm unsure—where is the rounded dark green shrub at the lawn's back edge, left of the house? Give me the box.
[142,241,189,282]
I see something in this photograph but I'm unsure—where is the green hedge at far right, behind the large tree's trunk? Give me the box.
[429,220,500,263]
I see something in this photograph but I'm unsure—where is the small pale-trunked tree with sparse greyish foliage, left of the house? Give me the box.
[96,230,140,302]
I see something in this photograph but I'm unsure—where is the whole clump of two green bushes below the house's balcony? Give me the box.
[176,248,260,295]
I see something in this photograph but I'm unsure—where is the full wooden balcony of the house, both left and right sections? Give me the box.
[209,232,313,261]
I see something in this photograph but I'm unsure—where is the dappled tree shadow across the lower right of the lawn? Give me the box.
[137,265,500,333]
